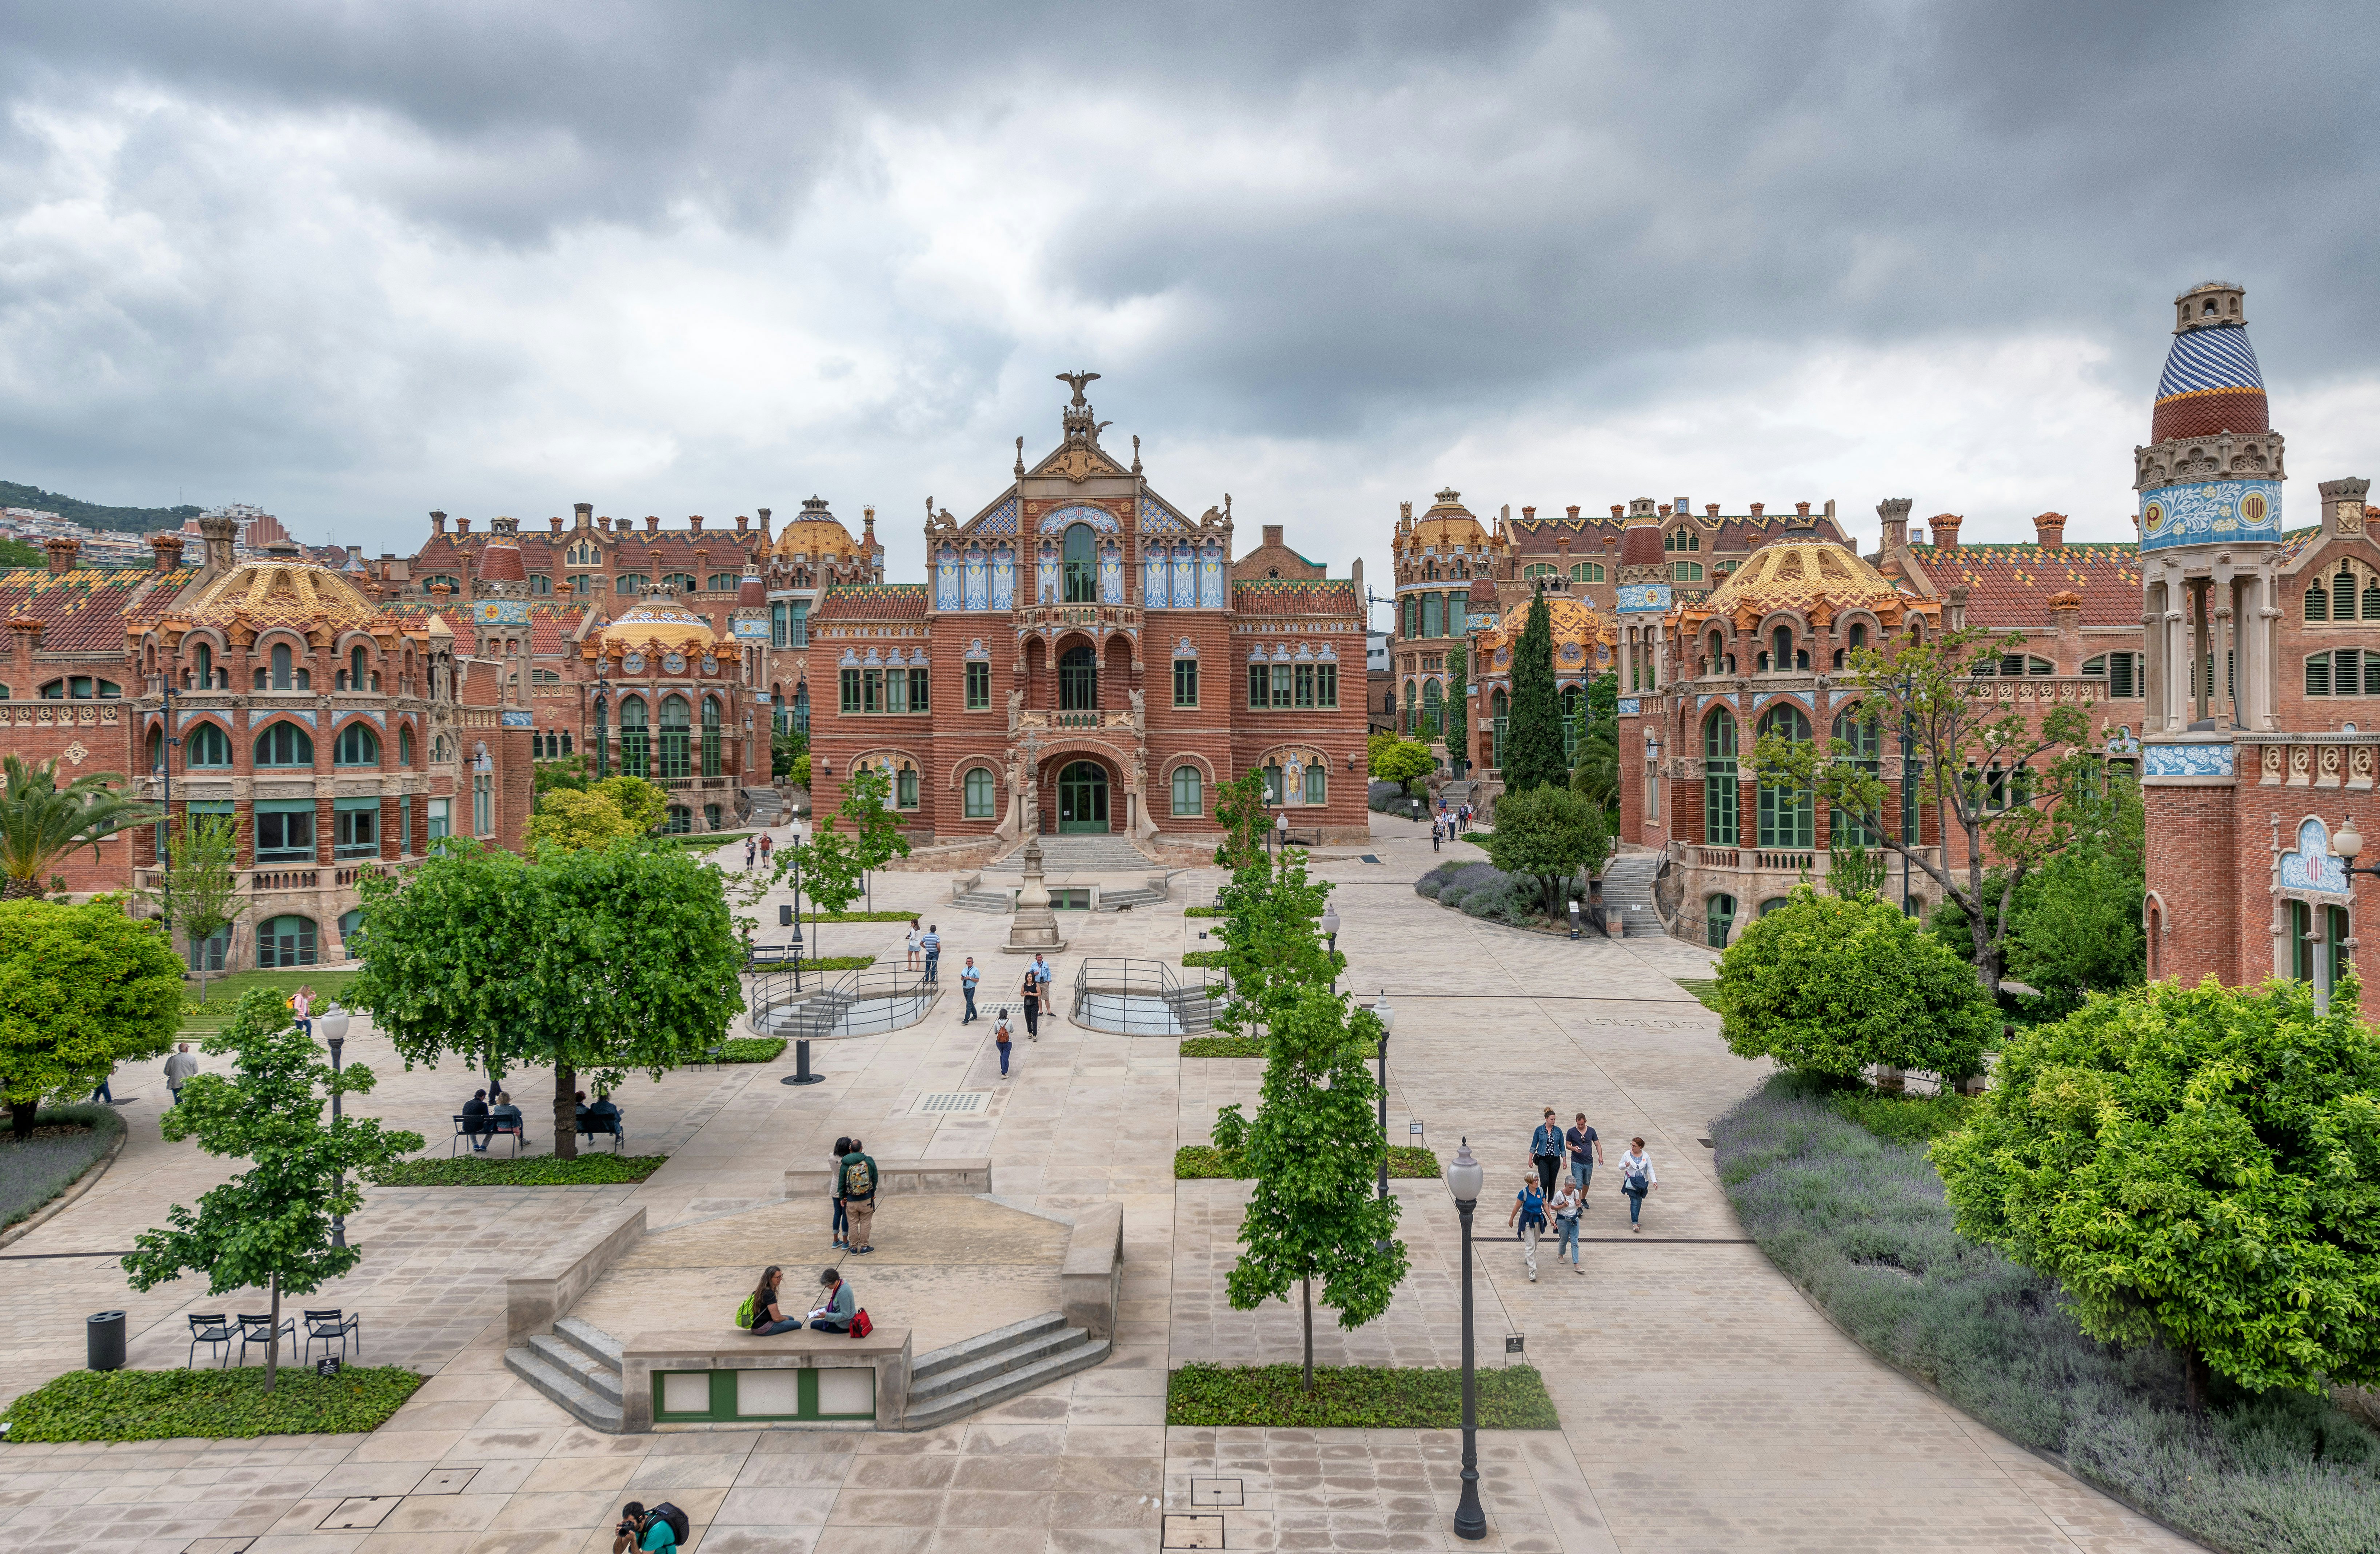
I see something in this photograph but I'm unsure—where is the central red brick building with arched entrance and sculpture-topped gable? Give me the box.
[807,374,1369,852]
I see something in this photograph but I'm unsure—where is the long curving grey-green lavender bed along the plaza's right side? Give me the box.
[1711,1073,2380,1554]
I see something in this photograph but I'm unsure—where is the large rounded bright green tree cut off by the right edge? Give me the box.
[1933,976,2380,1409]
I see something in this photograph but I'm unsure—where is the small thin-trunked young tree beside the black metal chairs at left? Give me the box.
[124,988,424,1392]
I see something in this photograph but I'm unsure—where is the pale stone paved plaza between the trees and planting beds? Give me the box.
[0,816,2195,1554]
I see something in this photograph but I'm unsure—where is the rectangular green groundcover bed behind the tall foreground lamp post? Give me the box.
[1166,1364,1561,1430]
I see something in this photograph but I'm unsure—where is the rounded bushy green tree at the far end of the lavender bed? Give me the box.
[1714,885,1999,1080]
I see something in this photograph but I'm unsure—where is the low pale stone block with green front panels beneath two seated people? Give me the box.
[619,1326,909,1435]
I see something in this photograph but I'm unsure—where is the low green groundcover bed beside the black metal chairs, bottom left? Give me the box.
[7,1361,428,1442]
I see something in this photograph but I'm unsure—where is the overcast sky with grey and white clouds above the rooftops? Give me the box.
[0,0,2380,576]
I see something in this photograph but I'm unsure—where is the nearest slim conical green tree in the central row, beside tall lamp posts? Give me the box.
[1214,976,1407,1392]
